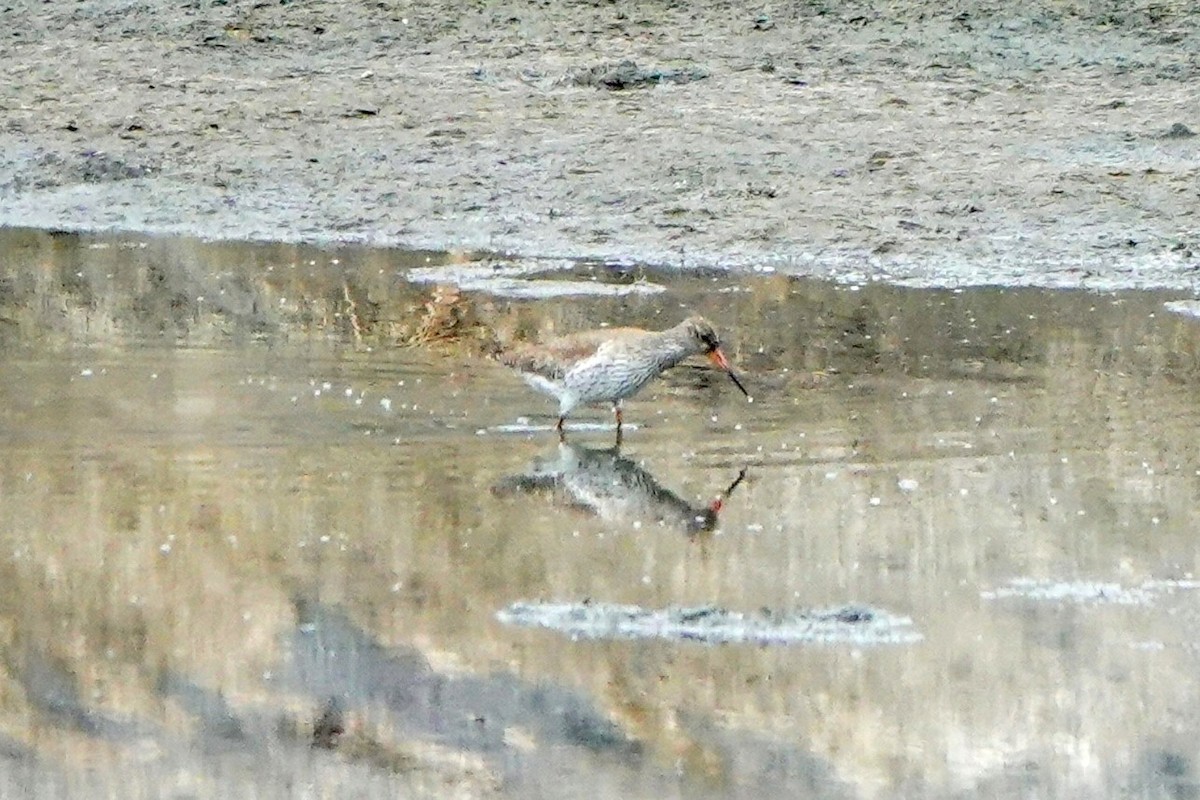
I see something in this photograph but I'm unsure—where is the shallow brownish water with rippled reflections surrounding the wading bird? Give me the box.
[0,231,1200,798]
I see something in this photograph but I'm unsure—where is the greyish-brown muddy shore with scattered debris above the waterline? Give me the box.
[0,0,1200,288]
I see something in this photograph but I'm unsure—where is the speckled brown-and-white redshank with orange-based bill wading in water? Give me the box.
[500,317,754,441]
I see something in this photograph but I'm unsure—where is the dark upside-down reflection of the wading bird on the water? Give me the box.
[492,441,746,534]
